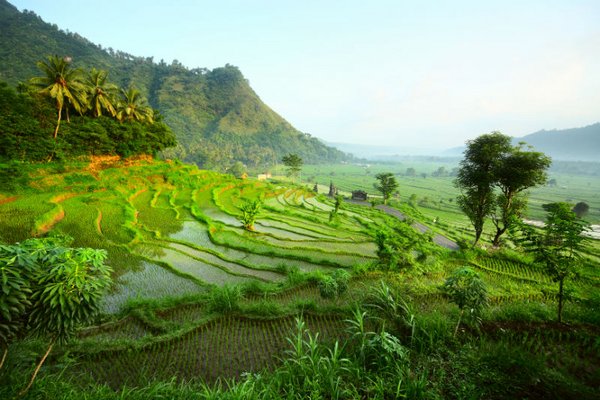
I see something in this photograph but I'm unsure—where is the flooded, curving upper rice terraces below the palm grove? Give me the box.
[0,163,376,312]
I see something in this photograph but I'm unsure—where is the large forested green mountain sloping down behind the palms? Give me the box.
[0,0,347,169]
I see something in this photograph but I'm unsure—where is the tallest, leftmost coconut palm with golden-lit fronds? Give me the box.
[30,56,87,139]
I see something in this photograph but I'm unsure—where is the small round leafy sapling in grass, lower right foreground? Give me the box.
[442,267,488,336]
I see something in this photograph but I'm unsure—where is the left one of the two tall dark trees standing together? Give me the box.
[454,132,511,246]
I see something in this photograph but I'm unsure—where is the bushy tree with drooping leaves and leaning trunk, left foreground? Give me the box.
[0,238,111,396]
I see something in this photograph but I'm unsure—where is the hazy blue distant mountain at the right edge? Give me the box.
[515,122,600,161]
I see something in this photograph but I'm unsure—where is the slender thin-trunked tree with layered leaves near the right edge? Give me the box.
[521,203,588,322]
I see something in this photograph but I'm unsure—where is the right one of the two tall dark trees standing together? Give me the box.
[492,144,551,246]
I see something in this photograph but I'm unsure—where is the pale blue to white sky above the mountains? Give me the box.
[9,0,600,150]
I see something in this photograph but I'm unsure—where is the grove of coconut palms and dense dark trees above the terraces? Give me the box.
[0,56,175,161]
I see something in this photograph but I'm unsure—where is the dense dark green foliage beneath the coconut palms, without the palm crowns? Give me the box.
[0,79,175,161]
